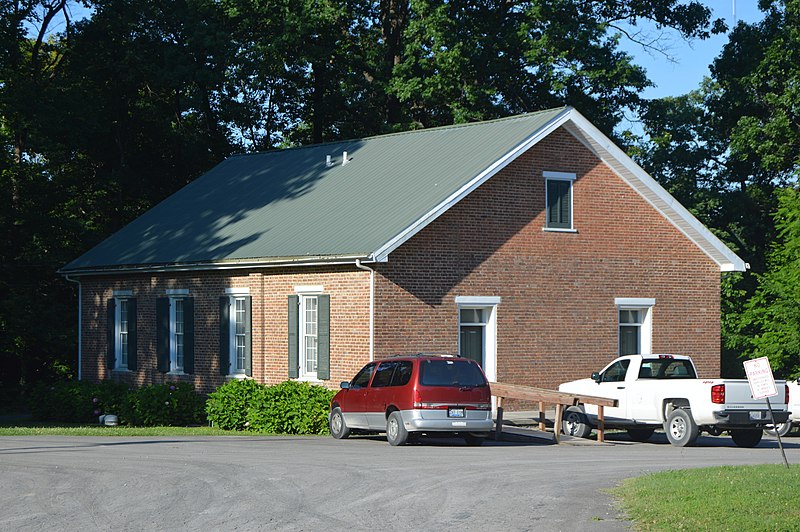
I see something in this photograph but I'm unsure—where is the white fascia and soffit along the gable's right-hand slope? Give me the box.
[569,109,748,272]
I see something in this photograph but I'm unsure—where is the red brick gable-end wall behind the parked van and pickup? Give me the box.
[375,124,720,388]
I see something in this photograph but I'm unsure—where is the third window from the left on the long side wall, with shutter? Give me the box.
[219,294,253,377]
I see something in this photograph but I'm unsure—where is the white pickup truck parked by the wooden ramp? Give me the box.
[558,355,789,447]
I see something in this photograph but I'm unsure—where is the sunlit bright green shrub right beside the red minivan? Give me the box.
[247,381,334,434]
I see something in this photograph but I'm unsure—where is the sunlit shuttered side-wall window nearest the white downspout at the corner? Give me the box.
[288,286,330,380]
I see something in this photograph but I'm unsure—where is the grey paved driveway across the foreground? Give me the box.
[0,435,800,531]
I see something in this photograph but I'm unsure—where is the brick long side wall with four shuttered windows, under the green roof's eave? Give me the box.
[82,267,369,392]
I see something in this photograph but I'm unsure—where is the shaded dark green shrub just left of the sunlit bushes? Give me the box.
[121,382,205,427]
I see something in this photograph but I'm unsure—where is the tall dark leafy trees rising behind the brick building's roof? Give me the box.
[6,0,800,400]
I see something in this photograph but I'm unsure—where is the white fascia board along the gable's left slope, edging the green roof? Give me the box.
[371,107,574,262]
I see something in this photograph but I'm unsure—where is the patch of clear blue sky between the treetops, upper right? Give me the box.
[622,0,764,98]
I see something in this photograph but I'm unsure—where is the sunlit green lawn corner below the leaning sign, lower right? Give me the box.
[612,465,800,531]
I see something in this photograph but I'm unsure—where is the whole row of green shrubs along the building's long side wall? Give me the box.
[29,379,334,434]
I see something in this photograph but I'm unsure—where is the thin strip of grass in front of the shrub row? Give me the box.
[0,422,247,436]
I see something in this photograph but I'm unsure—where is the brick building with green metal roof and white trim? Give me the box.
[62,108,746,392]
